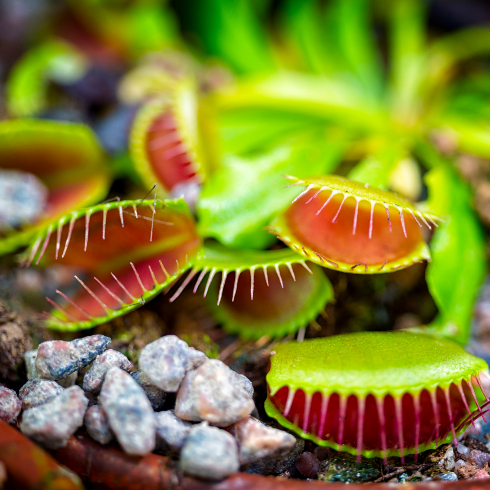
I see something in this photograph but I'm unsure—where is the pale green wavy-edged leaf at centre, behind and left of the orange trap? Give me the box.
[197,133,344,249]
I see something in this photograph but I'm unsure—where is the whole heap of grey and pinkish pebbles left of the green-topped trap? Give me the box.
[0,335,297,480]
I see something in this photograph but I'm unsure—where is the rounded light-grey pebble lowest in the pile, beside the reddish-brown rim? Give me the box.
[180,423,239,481]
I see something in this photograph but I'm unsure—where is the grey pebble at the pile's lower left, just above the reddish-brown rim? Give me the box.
[20,386,88,449]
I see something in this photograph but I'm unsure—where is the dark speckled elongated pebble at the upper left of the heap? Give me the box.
[35,335,111,380]
